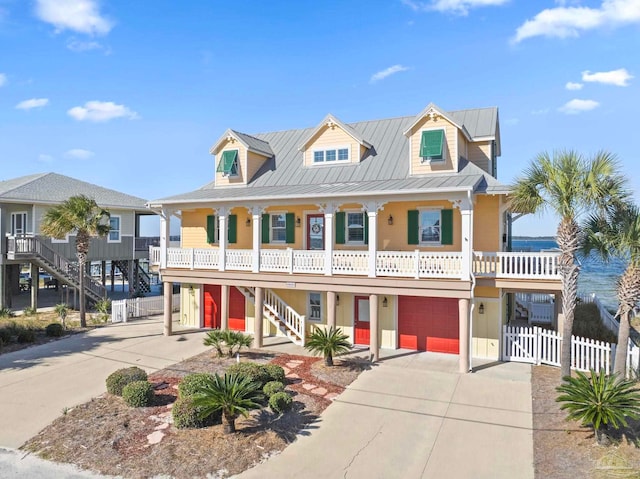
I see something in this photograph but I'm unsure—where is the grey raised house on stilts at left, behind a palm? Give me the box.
[0,173,157,307]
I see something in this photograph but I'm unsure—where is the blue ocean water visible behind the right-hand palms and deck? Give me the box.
[512,239,626,311]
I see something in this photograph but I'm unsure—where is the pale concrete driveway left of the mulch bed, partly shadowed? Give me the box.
[0,318,207,448]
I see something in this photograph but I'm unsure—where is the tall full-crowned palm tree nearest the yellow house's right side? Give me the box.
[510,150,628,378]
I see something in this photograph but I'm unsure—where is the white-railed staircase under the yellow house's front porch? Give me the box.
[236,286,306,346]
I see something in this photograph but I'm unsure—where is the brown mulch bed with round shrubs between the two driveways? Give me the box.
[22,350,367,479]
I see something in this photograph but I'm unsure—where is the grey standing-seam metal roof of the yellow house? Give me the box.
[151,107,505,205]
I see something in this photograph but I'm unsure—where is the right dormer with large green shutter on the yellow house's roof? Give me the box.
[404,103,471,175]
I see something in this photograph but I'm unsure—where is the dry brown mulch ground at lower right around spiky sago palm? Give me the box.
[531,366,640,479]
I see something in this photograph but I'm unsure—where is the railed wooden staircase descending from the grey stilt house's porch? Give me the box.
[7,236,106,302]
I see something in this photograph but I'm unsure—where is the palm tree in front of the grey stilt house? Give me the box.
[40,195,111,328]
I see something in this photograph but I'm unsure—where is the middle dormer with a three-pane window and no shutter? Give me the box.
[298,114,371,167]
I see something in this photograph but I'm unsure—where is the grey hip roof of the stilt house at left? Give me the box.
[0,173,146,211]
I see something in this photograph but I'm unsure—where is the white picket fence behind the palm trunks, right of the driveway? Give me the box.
[502,325,640,376]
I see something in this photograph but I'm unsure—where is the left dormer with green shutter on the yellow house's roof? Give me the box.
[209,129,273,186]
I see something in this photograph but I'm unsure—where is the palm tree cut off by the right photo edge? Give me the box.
[582,204,640,377]
